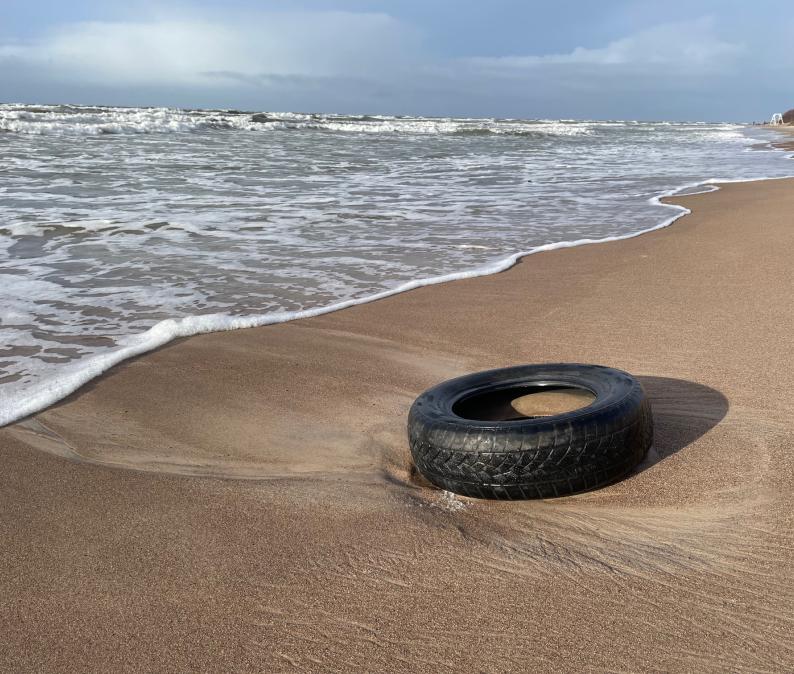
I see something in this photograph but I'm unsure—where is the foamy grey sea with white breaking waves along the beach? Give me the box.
[0,104,794,425]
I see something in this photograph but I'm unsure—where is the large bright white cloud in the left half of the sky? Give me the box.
[0,11,416,86]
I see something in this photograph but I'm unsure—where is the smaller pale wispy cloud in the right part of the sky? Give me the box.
[467,17,744,74]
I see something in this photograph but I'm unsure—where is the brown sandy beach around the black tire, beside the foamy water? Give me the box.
[0,176,794,672]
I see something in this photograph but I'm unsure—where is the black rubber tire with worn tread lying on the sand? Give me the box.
[408,364,653,499]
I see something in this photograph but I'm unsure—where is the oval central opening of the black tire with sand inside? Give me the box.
[452,384,596,421]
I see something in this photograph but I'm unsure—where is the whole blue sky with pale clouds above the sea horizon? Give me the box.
[0,0,794,121]
